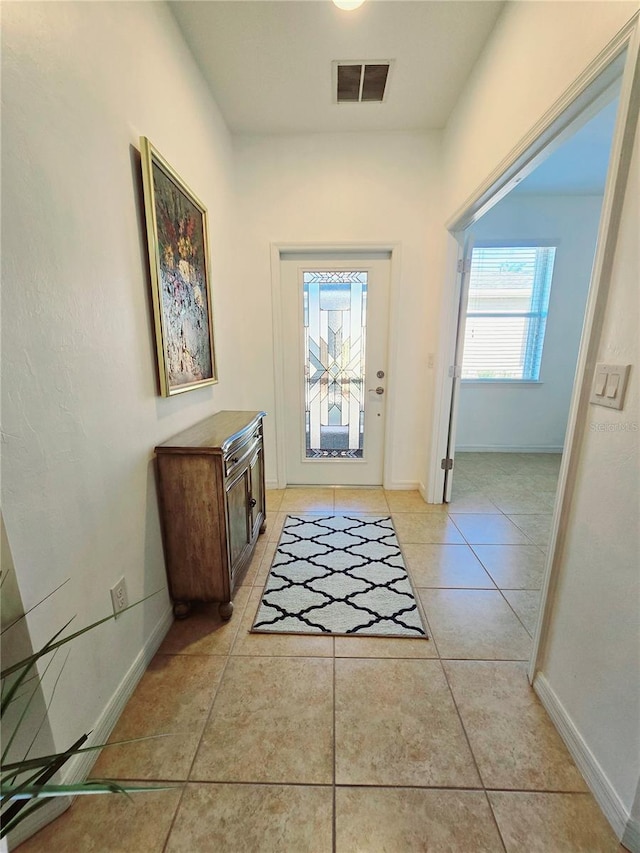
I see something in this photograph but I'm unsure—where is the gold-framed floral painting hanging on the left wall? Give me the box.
[140,136,217,397]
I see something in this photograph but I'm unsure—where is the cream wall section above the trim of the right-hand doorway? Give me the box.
[443,0,638,219]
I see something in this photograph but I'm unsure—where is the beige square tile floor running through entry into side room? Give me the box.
[20,454,623,853]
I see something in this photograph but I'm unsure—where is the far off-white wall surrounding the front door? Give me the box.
[235,133,440,488]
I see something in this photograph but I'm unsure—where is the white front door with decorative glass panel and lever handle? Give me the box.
[281,255,391,486]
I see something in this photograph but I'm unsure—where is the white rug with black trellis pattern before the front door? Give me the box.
[252,515,427,639]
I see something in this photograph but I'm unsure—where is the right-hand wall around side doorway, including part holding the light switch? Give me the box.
[444,2,640,830]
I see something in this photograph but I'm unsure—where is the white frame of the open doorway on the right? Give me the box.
[428,13,640,684]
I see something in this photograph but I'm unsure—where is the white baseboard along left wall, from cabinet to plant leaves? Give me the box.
[8,608,173,850]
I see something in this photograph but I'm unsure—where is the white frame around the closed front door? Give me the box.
[271,241,401,489]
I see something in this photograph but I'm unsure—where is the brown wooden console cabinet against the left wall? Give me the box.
[155,412,266,619]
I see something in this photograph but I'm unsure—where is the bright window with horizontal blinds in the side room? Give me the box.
[462,246,556,382]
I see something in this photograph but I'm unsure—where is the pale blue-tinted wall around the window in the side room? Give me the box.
[456,193,602,451]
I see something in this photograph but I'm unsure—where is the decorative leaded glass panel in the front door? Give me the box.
[302,270,368,460]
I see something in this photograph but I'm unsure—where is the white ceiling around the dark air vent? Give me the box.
[169,0,504,134]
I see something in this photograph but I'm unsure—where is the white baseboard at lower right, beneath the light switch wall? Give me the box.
[533,674,640,853]
